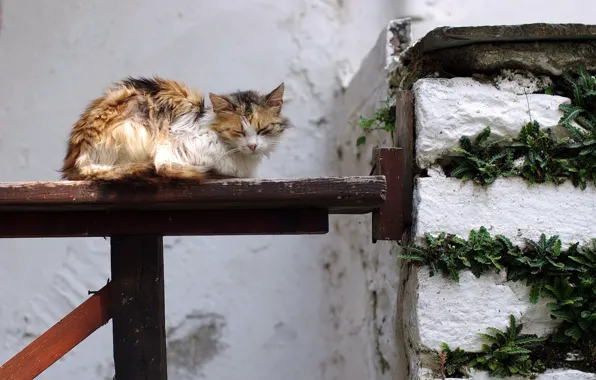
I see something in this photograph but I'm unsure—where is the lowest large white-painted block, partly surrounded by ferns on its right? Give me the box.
[416,267,556,351]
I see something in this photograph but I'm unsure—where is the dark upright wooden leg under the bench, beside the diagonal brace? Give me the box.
[111,235,168,380]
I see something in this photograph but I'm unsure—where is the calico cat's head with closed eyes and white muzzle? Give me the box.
[209,83,290,155]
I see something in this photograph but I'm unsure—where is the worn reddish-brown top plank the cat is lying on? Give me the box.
[0,176,386,214]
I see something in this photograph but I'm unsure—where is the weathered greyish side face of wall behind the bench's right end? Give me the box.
[327,21,404,380]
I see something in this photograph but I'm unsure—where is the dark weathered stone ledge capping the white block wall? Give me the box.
[392,23,596,89]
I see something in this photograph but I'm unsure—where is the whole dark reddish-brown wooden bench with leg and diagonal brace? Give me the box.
[0,148,411,380]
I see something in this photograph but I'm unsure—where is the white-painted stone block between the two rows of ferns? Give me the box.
[414,177,596,244]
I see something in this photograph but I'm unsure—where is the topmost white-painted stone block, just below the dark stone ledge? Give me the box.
[412,78,570,168]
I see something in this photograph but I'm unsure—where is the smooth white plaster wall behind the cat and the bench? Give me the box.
[0,0,398,380]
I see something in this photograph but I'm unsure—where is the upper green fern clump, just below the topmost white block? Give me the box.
[450,69,596,190]
